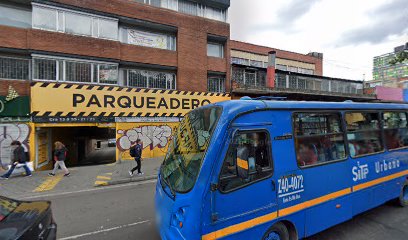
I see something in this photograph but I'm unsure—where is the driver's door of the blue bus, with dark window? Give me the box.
[212,126,277,236]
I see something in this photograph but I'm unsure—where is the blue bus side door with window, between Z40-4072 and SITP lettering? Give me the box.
[293,112,352,236]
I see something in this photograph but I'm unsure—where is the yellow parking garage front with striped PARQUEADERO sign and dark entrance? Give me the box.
[31,82,230,168]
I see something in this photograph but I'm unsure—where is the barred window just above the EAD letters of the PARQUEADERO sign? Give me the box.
[127,69,176,89]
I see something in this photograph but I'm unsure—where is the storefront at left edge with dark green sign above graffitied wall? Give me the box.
[0,80,33,165]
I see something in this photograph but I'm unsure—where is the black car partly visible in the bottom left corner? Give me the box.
[0,196,57,240]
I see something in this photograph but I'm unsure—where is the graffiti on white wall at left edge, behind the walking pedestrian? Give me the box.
[0,124,30,164]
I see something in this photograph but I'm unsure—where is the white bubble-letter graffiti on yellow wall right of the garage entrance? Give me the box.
[117,125,173,151]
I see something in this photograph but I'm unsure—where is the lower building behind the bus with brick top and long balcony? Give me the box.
[230,41,375,101]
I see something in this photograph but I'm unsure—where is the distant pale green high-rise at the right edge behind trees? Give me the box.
[373,42,408,88]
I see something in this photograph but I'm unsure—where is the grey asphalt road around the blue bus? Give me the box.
[14,180,408,240]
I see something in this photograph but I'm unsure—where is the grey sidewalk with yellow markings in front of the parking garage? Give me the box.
[0,158,163,199]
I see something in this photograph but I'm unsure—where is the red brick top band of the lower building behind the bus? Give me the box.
[230,40,323,76]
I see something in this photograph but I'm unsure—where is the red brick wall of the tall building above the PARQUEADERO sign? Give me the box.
[0,0,230,91]
